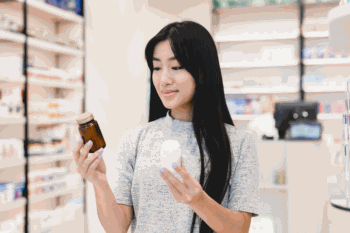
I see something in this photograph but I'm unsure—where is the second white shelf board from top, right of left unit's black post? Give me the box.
[28,37,83,57]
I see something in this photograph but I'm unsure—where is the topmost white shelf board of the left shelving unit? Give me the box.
[17,0,84,24]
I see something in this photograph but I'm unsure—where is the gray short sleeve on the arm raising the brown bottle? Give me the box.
[108,129,137,206]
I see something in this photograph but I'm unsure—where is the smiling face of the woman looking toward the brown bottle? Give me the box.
[153,41,195,117]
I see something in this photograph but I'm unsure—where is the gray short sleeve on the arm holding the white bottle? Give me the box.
[228,131,260,217]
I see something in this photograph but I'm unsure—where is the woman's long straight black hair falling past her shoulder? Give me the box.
[145,20,234,233]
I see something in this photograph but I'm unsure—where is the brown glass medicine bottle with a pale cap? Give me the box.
[77,112,106,153]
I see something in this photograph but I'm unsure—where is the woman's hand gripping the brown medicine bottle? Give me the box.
[73,140,107,186]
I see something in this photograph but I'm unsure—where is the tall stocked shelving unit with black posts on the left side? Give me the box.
[0,0,84,233]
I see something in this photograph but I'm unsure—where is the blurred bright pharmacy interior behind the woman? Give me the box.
[0,0,350,233]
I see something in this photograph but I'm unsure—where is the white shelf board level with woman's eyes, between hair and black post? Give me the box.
[220,60,299,69]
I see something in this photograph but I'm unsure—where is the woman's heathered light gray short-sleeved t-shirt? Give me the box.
[109,110,261,233]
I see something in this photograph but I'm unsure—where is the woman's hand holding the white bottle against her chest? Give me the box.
[161,158,204,205]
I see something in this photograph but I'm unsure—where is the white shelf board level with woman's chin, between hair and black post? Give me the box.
[225,86,299,95]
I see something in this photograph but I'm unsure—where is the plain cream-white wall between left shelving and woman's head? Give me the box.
[85,0,210,232]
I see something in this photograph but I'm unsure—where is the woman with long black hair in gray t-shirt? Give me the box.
[74,21,260,233]
